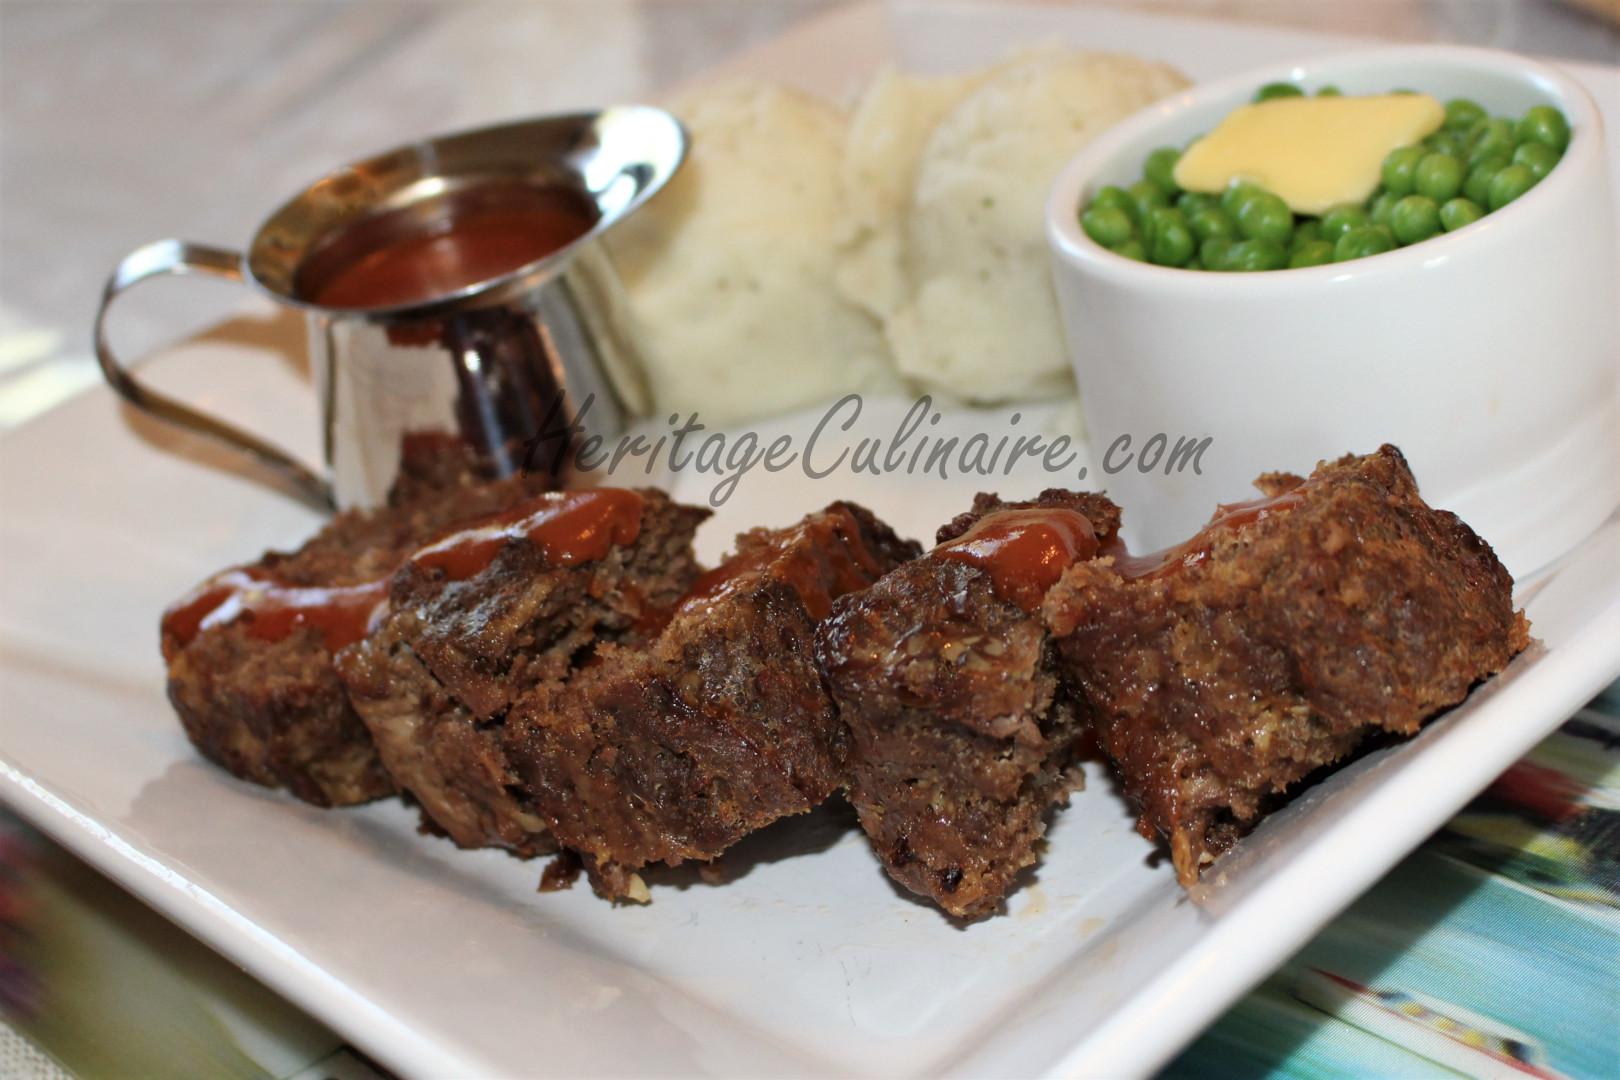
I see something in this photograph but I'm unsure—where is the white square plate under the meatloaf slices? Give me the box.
[0,5,1620,1077]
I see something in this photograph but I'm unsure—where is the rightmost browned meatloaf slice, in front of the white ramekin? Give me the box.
[1047,445,1529,884]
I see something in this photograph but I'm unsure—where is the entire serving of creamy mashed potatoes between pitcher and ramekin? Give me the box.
[609,55,1186,426]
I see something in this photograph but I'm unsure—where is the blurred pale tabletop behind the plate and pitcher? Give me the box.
[0,0,1620,429]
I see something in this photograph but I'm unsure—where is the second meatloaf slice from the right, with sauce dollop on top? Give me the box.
[818,491,1119,918]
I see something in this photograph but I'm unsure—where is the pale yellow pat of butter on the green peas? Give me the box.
[1176,94,1445,214]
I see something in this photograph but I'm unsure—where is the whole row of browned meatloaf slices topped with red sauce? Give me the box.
[162,439,1529,918]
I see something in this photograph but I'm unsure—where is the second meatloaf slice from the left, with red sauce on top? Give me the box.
[339,489,708,855]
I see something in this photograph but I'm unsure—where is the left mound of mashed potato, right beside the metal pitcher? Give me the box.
[609,83,902,426]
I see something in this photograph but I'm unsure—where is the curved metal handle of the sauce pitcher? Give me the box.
[96,240,335,510]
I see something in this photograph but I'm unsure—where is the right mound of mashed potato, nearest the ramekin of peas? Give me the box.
[841,49,1187,402]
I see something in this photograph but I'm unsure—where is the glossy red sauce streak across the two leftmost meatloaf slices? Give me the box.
[162,487,642,661]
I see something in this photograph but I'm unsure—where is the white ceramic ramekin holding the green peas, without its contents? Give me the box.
[1047,47,1620,575]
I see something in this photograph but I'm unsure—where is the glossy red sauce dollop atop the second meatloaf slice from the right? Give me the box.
[933,507,1098,612]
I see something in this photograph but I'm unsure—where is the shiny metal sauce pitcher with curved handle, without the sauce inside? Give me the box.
[96,105,687,508]
